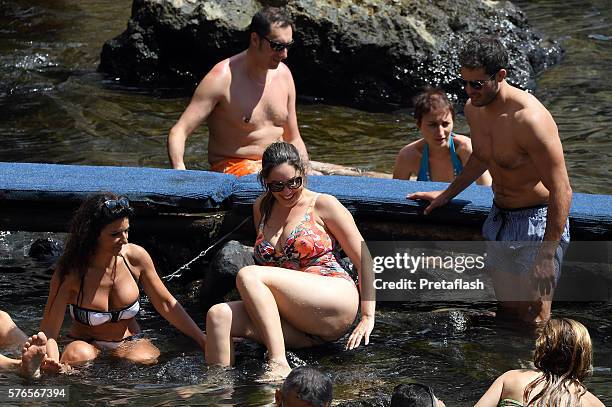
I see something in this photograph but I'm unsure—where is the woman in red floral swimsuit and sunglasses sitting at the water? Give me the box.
[206,142,375,376]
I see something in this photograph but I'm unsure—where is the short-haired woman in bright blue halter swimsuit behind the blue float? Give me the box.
[393,88,491,185]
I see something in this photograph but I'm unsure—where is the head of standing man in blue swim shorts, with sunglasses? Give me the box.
[459,37,508,107]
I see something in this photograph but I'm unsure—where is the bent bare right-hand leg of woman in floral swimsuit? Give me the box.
[236,266,359,376]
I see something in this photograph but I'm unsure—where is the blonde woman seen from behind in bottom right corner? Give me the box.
[475,318,603,407]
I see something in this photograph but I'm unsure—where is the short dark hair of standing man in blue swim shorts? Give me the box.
[459,37,508,75]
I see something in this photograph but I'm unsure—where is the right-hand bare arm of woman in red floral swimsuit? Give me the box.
[316,195,376,349]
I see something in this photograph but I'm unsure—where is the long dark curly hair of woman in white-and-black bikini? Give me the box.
[56,192,132,285]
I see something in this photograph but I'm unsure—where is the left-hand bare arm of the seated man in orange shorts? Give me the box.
[168,61,229,170]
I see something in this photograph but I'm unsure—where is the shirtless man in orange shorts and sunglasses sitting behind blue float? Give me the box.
[168,7,308,176]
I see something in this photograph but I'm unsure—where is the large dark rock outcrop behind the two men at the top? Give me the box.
[100,0,562,108]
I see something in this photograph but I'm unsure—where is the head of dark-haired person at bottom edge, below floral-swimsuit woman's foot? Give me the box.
[275,366,333,407]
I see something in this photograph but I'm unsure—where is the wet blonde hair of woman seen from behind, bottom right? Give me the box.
[523,318,593,407]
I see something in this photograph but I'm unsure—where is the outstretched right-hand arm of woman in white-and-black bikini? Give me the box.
[126,244,206,350]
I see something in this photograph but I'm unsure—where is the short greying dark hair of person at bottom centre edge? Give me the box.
[281,366,333,407]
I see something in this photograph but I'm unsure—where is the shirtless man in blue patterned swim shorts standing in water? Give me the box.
[408,38,572,323]
